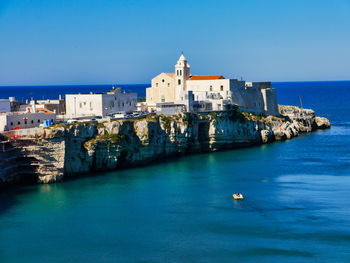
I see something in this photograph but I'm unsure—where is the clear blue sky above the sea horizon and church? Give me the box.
[0,0,350,85]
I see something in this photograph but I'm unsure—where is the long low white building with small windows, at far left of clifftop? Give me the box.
[0,112,56,132]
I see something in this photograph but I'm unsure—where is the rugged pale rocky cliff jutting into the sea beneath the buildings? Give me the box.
[0,106,330,187]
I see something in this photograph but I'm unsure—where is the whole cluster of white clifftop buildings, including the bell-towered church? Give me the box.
[0,54,279,132]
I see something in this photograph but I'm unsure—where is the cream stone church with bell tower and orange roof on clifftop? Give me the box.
[146,54,279,115]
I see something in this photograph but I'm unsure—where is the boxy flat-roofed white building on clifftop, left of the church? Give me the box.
[66,88,137,118]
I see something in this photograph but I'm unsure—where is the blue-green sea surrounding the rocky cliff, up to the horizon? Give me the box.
[0,81,350,263]
